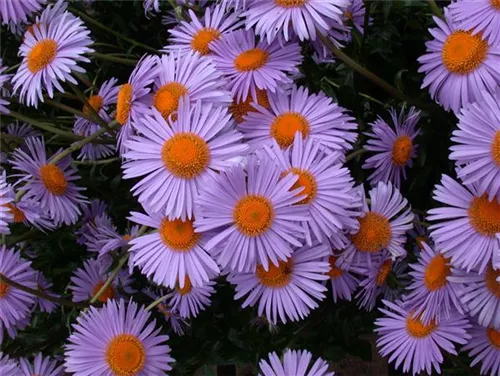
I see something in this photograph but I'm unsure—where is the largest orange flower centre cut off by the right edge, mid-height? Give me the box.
[468,195,500,236]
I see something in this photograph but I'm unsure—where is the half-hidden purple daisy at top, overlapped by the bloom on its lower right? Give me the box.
[164,5,243,56]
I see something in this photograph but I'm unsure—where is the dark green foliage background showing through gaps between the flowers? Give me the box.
[0,0,478,376]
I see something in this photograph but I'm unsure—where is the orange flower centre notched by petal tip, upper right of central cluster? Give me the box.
[271,112,310,148]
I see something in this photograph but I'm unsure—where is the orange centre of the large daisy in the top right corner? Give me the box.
[442,30,488,74]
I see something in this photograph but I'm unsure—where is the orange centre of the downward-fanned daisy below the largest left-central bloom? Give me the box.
[159,218,200,252]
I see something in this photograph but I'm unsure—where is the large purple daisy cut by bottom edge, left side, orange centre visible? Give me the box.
[64,299,174,376]
